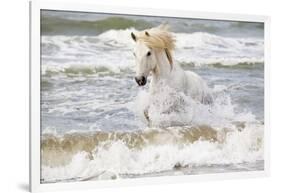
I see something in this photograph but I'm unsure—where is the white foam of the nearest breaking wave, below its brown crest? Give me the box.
[42,122,263,181]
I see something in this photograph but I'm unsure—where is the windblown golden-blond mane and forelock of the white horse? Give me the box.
[137,25,176,65]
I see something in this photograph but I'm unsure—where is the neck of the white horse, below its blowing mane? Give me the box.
[152,50,171,83]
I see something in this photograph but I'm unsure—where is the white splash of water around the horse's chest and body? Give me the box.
[132,82,256,128]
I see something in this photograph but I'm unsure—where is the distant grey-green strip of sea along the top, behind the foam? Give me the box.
[41,10,264,37]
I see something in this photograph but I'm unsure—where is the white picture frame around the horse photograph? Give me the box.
[30,1,270,192]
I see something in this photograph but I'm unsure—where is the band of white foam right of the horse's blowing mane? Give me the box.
[176,32,264,65]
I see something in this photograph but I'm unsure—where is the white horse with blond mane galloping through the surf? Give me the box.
[131,25,212,122]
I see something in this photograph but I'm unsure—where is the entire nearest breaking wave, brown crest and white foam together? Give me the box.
[41,122,263,183]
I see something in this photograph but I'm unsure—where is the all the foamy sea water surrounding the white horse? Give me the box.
[41,11,264,183]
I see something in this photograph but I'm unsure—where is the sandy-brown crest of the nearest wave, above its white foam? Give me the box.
[41,126,219,166]
